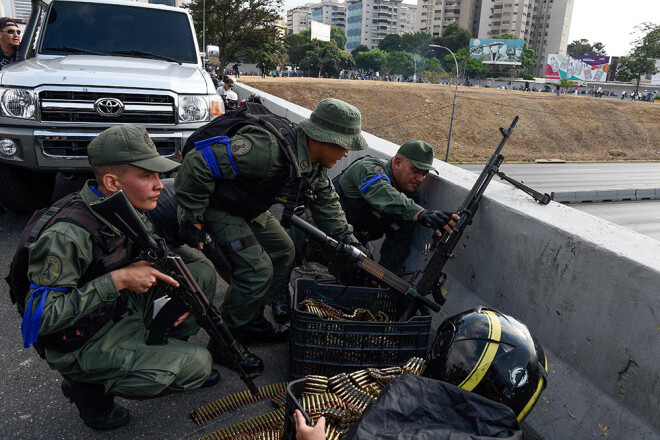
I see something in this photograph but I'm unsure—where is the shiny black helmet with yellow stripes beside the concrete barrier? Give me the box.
[424,307,548,422]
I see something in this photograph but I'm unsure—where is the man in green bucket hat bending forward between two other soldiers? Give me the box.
[175,98,367,342]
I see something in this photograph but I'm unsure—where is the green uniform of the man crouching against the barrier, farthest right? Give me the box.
[339,156,424,271]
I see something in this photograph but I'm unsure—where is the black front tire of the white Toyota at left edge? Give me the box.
[0,164,57,214]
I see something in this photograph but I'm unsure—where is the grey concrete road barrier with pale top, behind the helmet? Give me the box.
[235,84,660,440]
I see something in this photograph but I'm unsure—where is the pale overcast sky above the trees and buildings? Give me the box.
[284,0,660,56]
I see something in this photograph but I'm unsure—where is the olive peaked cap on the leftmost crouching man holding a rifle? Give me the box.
[87,125,180,173]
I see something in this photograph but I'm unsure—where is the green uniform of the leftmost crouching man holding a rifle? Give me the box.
[28,182,216,399]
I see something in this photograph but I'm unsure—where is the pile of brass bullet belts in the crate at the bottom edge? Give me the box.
[298,357,425,440]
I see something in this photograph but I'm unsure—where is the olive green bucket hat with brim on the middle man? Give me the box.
[299,98,367,151]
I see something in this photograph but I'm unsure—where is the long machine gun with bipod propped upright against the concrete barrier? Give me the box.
[413,116,552,304]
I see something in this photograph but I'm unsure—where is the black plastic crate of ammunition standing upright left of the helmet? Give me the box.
[289,278,431,378]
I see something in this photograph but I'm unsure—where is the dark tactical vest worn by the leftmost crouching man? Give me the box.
[7,193,134,357]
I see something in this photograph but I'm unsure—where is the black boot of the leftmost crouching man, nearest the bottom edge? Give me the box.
[62,379,131,430]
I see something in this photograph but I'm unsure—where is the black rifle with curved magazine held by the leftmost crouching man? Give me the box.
[90,190,259,396]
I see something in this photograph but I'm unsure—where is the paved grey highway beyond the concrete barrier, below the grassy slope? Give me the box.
[459,162,660,240]
